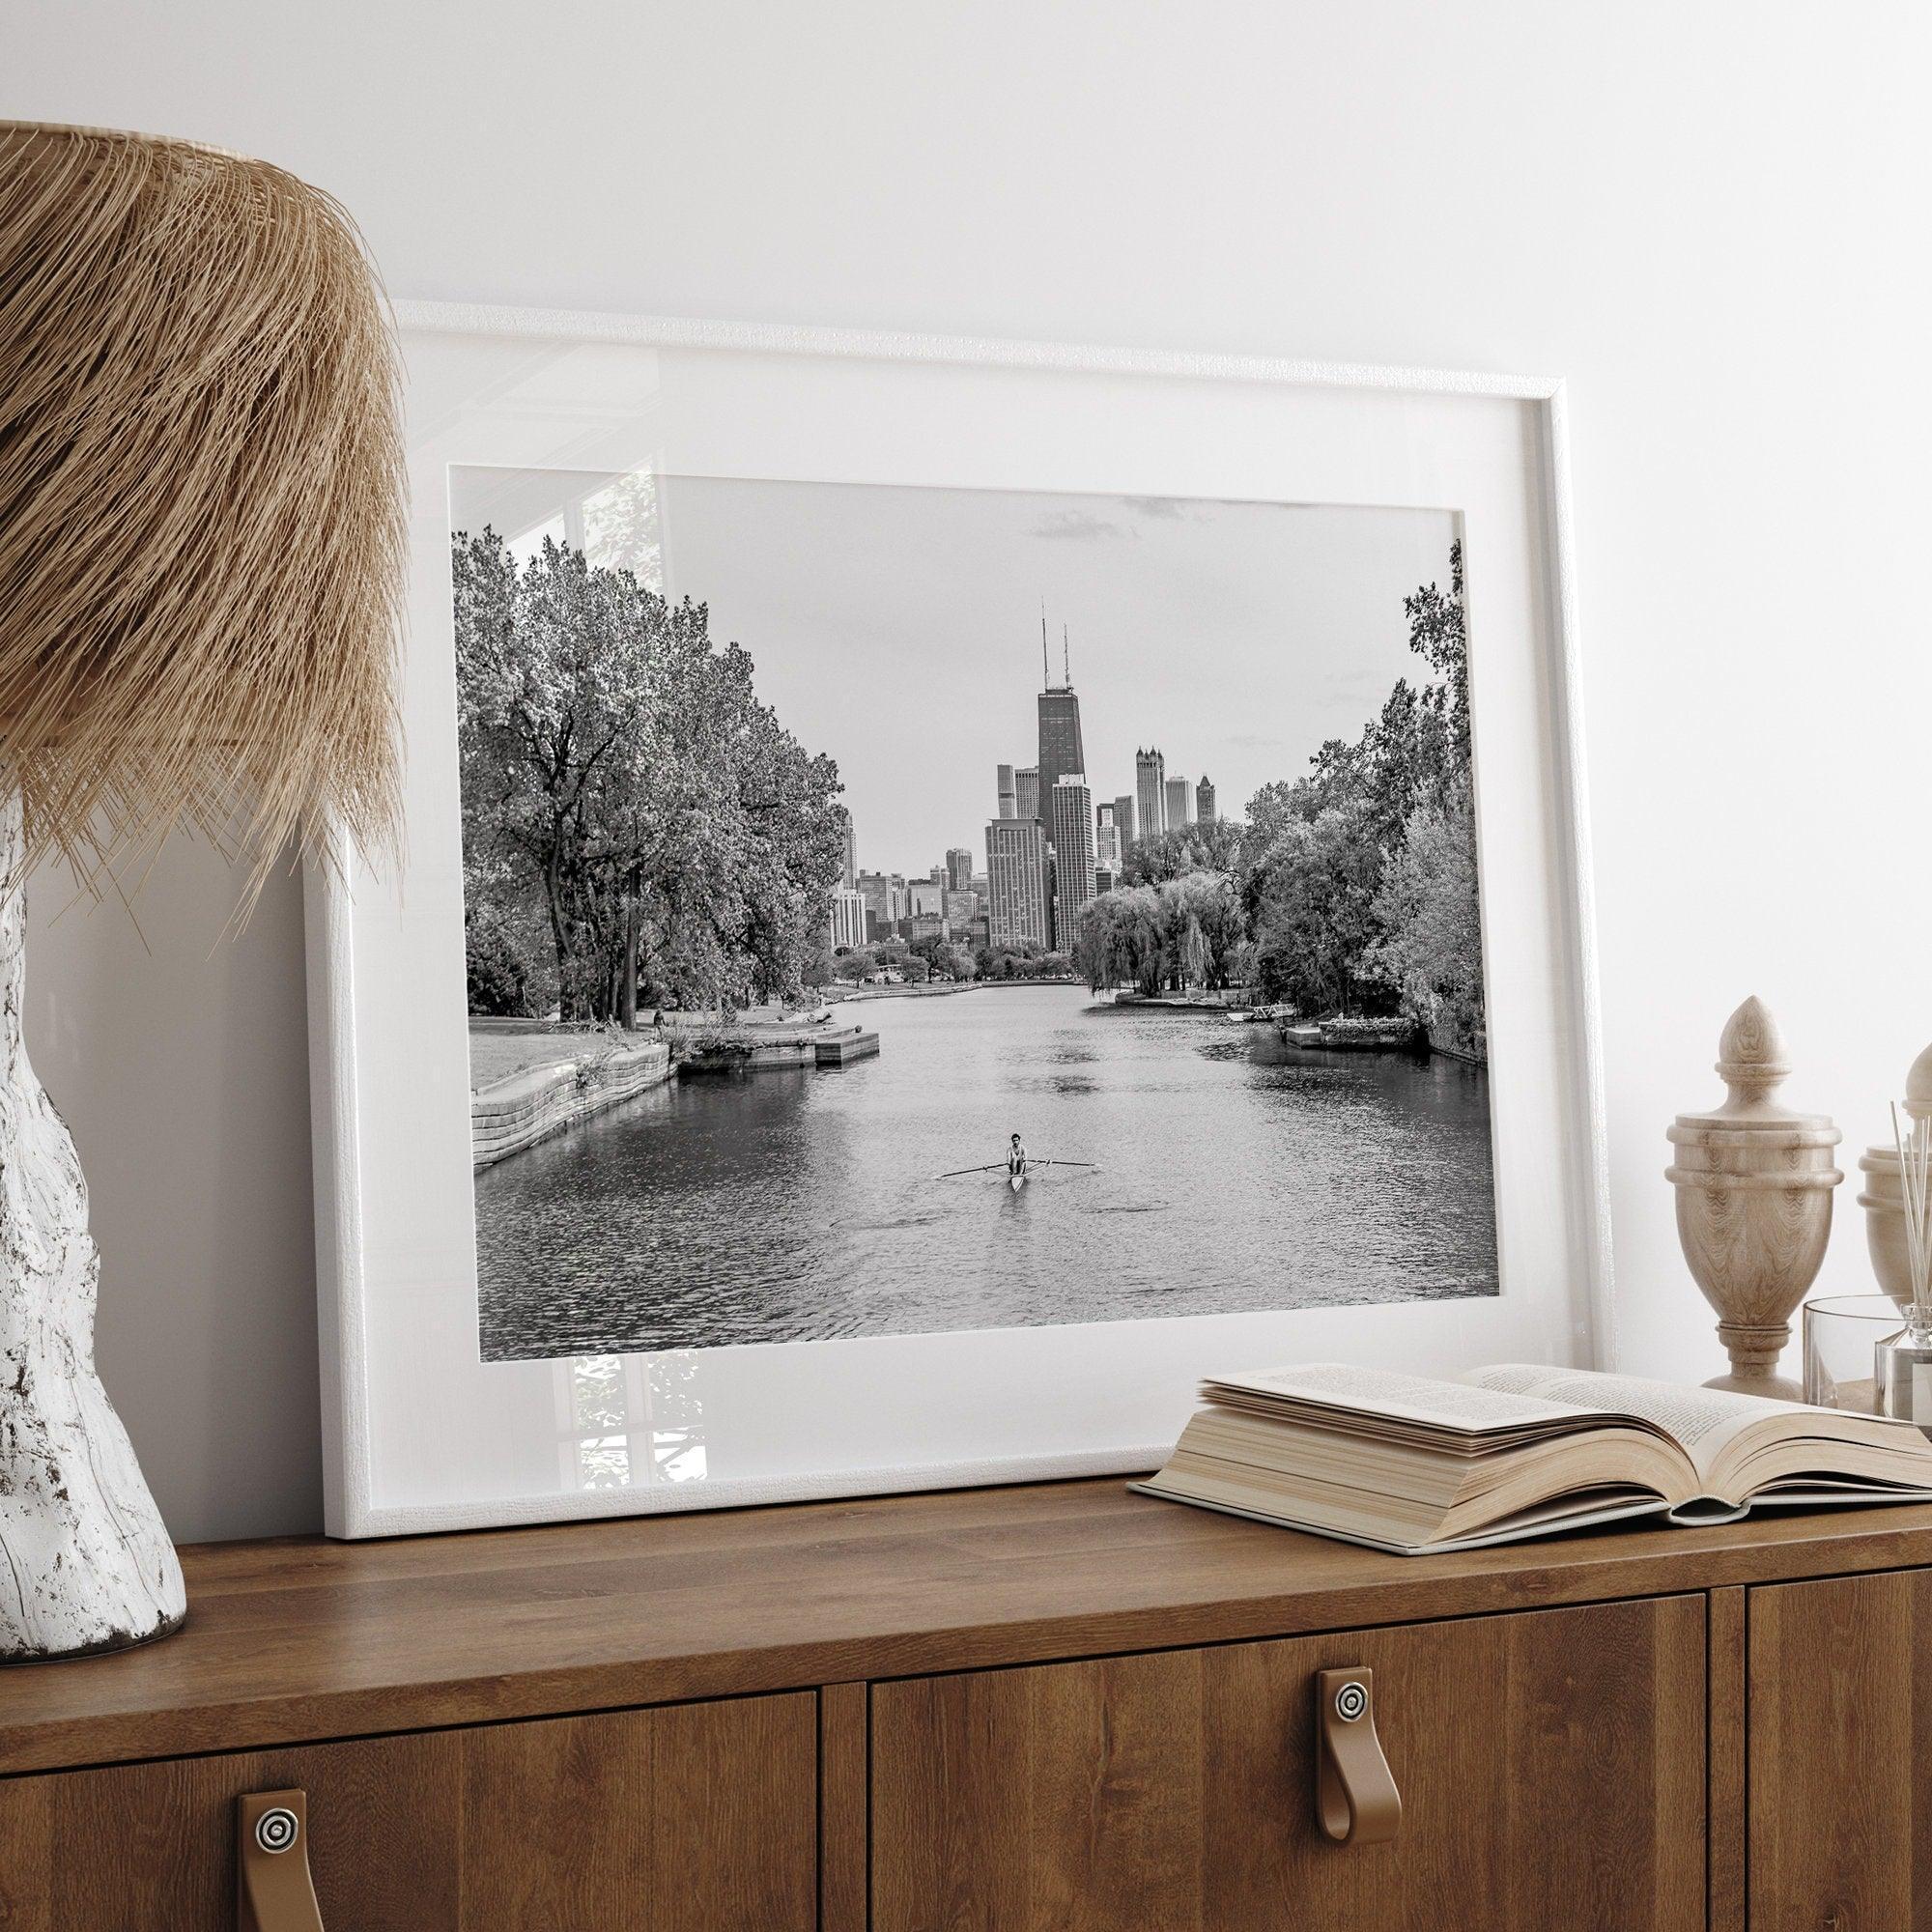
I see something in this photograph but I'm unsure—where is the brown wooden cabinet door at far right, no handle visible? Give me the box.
[1745,1571,1932,1932]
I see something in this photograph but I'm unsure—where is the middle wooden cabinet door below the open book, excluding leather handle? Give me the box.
[871,1596,1704,1932]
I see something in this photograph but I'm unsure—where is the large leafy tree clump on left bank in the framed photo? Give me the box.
[452,522,844,1024]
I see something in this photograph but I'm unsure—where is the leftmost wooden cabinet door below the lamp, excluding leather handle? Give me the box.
[0,1692,817,1932]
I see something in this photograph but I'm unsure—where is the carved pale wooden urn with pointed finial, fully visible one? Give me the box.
[1665,997,1845,1403]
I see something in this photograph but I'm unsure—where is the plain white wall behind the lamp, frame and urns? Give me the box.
[0,0,1932,1538]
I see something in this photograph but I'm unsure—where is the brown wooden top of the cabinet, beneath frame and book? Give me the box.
[0,1480,1932,1774]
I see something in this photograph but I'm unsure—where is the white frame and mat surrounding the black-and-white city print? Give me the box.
[307,303,1615,1538]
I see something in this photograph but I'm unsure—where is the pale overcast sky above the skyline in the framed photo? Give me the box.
[454,471,1453,875]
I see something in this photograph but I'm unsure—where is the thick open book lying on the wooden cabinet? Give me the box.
[1134,1362,1932,1555]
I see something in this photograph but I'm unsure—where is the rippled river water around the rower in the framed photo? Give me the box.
[475,985,1497,1360]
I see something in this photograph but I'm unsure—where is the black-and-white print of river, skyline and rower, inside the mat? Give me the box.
[450,466,1497,1360]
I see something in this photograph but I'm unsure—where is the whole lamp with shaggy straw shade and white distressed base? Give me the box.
[0,124,406,1660]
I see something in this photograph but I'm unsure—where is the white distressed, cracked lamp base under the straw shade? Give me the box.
[0,794,187,1663]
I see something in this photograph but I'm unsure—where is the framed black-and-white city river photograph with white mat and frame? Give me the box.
[309,303,1611,1536]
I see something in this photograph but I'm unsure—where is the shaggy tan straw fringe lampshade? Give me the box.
[0,124,408,885]
